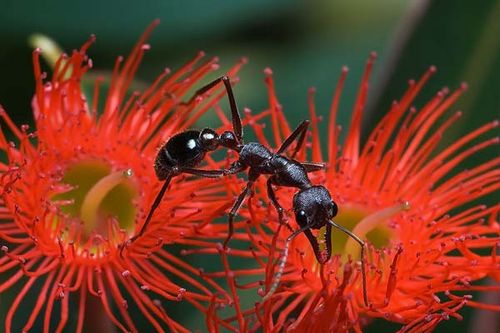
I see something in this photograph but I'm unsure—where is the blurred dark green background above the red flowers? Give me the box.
[0,0,500,332]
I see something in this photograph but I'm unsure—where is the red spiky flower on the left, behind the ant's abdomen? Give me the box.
[0,22,240,332]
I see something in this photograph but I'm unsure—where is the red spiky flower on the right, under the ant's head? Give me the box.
[204,55,500,332]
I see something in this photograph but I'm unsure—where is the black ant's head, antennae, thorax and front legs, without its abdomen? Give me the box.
[217,82,368,306]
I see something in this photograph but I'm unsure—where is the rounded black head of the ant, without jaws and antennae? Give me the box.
[293,186,338,229]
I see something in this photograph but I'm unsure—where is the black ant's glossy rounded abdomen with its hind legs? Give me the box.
[125,76,241,244]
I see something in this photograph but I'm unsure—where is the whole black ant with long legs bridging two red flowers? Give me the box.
[122,76,368,305]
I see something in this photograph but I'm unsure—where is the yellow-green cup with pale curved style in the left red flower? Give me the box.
[53,161,137,241]
